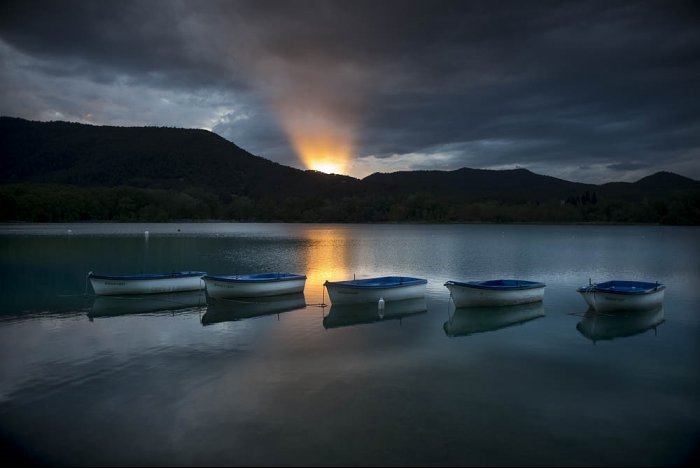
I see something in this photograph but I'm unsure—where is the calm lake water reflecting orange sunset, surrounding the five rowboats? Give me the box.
[0,223,700,466]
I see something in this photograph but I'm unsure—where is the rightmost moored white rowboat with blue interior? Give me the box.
[576,280,666,312]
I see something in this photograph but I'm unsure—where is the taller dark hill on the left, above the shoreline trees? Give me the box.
[0,117,358,198]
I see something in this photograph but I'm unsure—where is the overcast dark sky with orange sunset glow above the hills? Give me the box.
[0,0,700,183]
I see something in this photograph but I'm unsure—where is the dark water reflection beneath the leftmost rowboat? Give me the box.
[87,290,206,320]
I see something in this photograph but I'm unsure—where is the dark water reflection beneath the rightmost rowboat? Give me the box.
[576,306,665,343]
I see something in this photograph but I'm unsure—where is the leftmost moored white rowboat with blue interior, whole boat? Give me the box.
[88,271,206,296]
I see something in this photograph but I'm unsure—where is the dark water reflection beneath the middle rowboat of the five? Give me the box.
[323,297,428,329]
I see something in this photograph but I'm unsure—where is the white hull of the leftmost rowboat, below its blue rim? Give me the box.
[90,276,204,296]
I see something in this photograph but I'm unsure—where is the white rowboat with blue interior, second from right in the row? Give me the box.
[445,279,546,307]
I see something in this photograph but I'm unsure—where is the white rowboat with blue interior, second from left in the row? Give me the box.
[203,273,306,299]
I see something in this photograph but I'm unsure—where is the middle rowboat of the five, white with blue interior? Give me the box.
[323,276,428,304]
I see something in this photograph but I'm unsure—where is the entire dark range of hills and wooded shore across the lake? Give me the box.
[0,117,700,224]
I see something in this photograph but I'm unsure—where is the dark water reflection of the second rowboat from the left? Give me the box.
[202,293,306,325]
